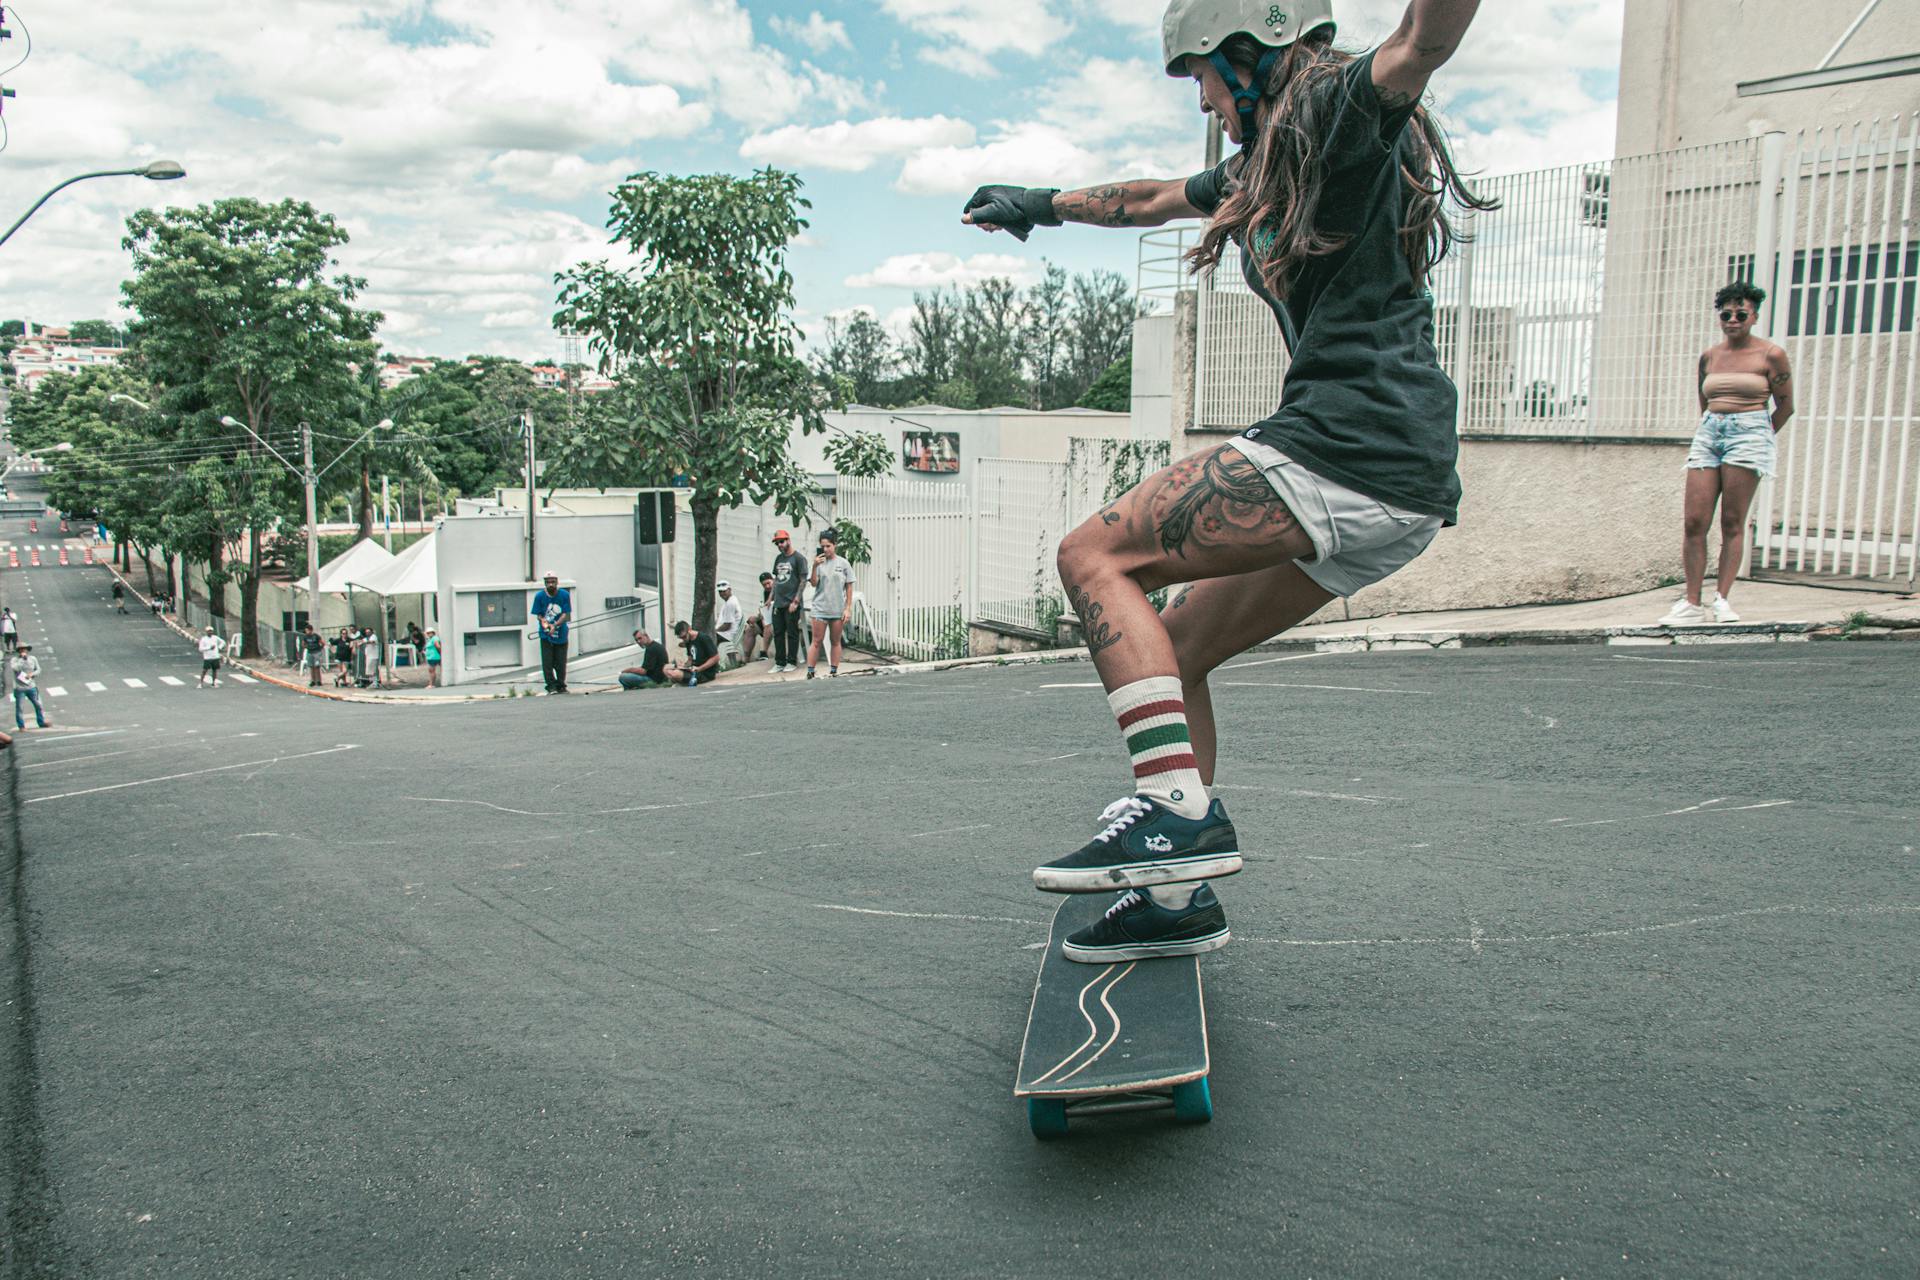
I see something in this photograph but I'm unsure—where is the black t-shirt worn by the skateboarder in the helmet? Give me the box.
[1187,54,1459,524]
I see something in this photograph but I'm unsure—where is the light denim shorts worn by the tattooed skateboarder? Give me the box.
[1227,436,1444,595]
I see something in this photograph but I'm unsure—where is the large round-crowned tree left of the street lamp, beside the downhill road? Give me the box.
[121,198,380,654]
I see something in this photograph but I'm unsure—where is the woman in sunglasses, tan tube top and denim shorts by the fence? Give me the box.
[1661,280,1793,626]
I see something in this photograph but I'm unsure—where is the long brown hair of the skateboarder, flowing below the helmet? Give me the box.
[1187,33,1500,297]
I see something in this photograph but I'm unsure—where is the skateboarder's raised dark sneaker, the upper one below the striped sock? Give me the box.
[1033,796,1240,894]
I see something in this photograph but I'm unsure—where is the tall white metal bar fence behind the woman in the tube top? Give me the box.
[1140,113,1920,581]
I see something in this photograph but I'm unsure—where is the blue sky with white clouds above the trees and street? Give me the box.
[0,0,1624,359]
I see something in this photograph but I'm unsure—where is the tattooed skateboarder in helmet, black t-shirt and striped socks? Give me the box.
[962,0,1492,963]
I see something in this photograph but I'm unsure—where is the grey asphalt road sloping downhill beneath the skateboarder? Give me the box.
[0,498,1920,1276]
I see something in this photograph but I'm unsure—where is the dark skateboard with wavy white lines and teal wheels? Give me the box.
[1014,894,1213,1138]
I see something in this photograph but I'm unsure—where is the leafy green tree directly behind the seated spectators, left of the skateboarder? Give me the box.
[553,169,887,629]
